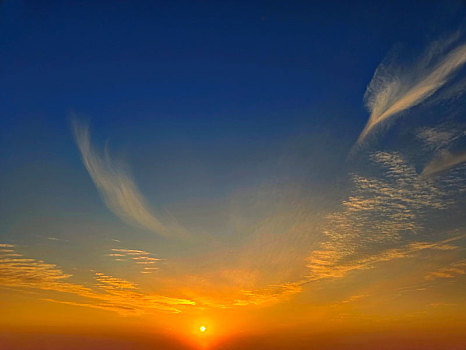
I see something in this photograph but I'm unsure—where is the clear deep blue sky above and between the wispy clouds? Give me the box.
[1,1,464,216]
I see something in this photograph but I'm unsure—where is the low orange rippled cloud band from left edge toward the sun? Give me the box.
[0,245,196,315]
